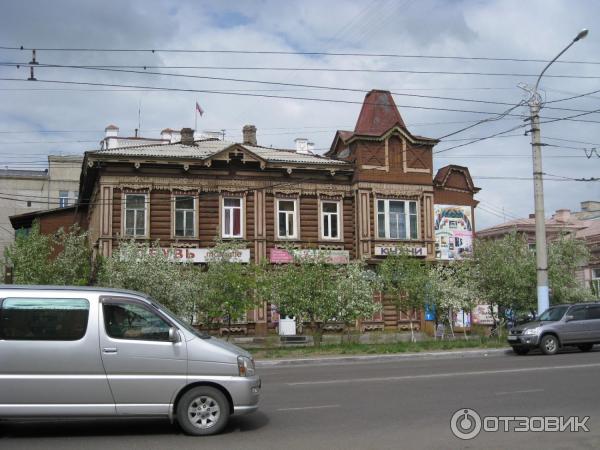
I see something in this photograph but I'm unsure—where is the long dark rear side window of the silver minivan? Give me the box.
[0,298,90,341]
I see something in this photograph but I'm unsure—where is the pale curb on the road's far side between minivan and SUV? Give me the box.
[256,348,510,367]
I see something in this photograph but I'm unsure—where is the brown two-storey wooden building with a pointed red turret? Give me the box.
[13,90,478,333]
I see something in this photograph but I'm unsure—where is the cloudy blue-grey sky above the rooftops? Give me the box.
[0,0,600,228]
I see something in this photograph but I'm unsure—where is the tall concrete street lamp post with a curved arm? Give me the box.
[529,28,588,315]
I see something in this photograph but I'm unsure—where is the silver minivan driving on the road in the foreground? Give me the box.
[0,285,261,435]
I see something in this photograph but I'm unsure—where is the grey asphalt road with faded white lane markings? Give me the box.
[0,346,600,450]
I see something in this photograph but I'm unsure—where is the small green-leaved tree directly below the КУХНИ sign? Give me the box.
[379,252,428,342]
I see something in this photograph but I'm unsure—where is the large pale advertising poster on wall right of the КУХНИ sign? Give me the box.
[434,205,473,260]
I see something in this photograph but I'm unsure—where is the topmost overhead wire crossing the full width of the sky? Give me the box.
[0,46,600,65]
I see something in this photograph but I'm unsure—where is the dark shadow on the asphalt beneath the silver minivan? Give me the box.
[0,412,269,438]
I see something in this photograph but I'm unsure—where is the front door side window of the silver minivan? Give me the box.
[102,302,171,341]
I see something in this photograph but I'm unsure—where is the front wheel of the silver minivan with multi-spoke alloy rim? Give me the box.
[177,386,230,436]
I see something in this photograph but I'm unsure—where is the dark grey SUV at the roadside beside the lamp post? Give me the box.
[508,303,600,355]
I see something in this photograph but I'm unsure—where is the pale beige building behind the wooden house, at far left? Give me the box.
[0,155,83,256]
